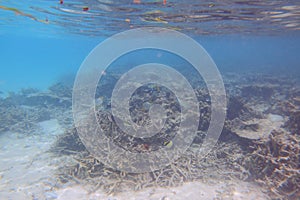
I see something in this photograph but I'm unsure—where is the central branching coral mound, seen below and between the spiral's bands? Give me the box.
[52,85,250,193]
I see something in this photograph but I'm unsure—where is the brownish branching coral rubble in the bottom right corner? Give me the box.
[247,131,300,199]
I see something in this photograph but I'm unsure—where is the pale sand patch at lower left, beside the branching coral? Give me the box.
[0,120,67,199]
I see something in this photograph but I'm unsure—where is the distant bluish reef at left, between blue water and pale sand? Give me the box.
[0,84,72,133]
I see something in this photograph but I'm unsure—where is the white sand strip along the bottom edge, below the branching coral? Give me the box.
[57,180,268,200]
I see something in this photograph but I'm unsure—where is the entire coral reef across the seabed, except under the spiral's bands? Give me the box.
[0,73,300,199]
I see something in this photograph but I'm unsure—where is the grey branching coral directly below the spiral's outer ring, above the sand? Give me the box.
[53,129,250,194]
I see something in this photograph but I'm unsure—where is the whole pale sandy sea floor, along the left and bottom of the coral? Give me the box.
[0,124,268,200]
